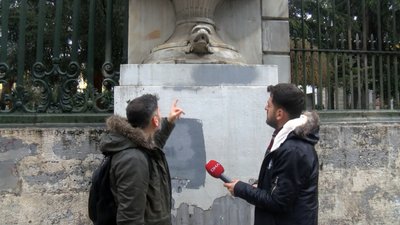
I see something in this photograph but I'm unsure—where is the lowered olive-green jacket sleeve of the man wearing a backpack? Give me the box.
[112,150,149,225]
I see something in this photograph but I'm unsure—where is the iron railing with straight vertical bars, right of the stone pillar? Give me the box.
[289,0,400,110]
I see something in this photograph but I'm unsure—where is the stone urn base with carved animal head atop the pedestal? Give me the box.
[143,0,245,64]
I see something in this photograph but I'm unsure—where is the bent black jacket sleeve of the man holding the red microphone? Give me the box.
[234,146,309,212]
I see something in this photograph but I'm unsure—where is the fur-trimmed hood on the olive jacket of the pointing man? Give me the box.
[100,115,154,154]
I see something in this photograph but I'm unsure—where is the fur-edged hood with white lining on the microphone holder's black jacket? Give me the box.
[271,111,319,152]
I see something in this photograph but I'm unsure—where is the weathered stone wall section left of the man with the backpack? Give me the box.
[0,127,104,225]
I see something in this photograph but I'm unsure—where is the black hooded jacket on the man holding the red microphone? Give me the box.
[234,113,319,225]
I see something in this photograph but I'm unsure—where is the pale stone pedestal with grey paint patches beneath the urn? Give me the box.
[114,64,278,218]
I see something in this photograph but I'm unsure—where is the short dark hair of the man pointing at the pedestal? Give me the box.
[126,94,158,128]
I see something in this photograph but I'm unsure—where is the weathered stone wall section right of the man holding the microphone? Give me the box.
[318,123,400,224]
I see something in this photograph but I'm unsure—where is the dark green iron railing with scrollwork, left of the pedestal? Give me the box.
[0,0,129,119]
